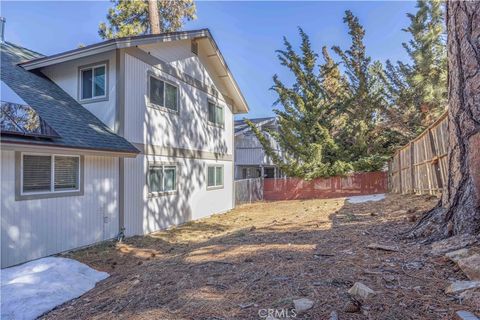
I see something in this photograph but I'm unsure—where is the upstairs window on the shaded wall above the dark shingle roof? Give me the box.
[80,64,107,100]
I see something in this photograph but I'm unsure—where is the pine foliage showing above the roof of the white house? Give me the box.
[98,0,196,39]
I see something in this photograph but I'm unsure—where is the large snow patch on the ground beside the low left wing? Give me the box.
[0,257,109,320]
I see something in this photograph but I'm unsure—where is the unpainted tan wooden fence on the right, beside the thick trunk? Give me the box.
[389,112,448,195]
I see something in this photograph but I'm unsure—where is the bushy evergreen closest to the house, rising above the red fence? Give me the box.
[247,29,351,179]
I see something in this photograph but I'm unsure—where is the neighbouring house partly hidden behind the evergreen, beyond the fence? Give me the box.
[235,117,284,180]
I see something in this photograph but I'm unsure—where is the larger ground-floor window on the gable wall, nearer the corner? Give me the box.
[147,164,177,194]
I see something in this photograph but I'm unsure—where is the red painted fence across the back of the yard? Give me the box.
[263,172,387,200]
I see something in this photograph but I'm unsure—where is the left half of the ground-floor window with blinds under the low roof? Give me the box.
[22,155,52,192]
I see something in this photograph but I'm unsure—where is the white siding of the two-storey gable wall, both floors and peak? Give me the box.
[125,41,233,236]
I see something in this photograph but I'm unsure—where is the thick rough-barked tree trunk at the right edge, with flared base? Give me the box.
[408,0,480,240]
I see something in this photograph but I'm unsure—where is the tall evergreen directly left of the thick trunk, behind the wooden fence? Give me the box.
[383,0,447,143]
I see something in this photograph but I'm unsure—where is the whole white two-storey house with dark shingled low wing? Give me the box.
[1,23,248,268]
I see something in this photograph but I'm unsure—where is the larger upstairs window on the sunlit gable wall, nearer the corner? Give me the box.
[149,76,178,111]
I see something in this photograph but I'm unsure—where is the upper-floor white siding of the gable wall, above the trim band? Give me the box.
[125,54,233,155]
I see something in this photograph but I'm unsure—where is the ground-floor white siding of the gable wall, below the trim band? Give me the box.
[125,155,233,236]
